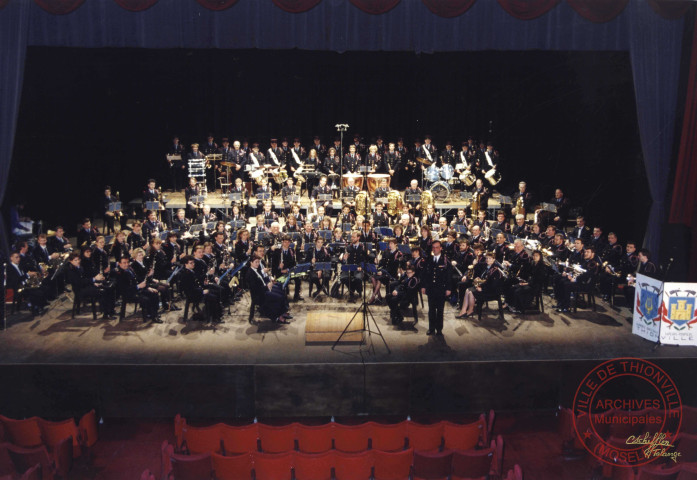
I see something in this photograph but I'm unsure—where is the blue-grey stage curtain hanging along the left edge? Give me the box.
[0,2,31,254]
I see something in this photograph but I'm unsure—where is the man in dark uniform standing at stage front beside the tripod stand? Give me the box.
[421,240,451,335]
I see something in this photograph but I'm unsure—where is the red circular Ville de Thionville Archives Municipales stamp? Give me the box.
[573,357,682,467]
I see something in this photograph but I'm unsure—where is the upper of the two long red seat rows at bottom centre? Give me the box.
[175,410,494,455]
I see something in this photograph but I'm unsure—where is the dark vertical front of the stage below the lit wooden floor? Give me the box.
[0,359,697,419]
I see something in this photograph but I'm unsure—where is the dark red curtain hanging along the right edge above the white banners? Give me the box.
[669,8,697,282]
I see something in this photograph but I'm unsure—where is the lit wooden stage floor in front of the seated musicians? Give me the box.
[0,284,695,365]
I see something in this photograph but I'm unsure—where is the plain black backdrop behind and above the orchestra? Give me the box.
[9,47,650,241]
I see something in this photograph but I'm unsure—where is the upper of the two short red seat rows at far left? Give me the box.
[0,410,98,458]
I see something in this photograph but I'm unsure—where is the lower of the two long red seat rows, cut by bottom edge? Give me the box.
[162,435,502,480]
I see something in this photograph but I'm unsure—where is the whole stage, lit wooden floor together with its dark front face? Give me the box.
[0,289,697,418]
